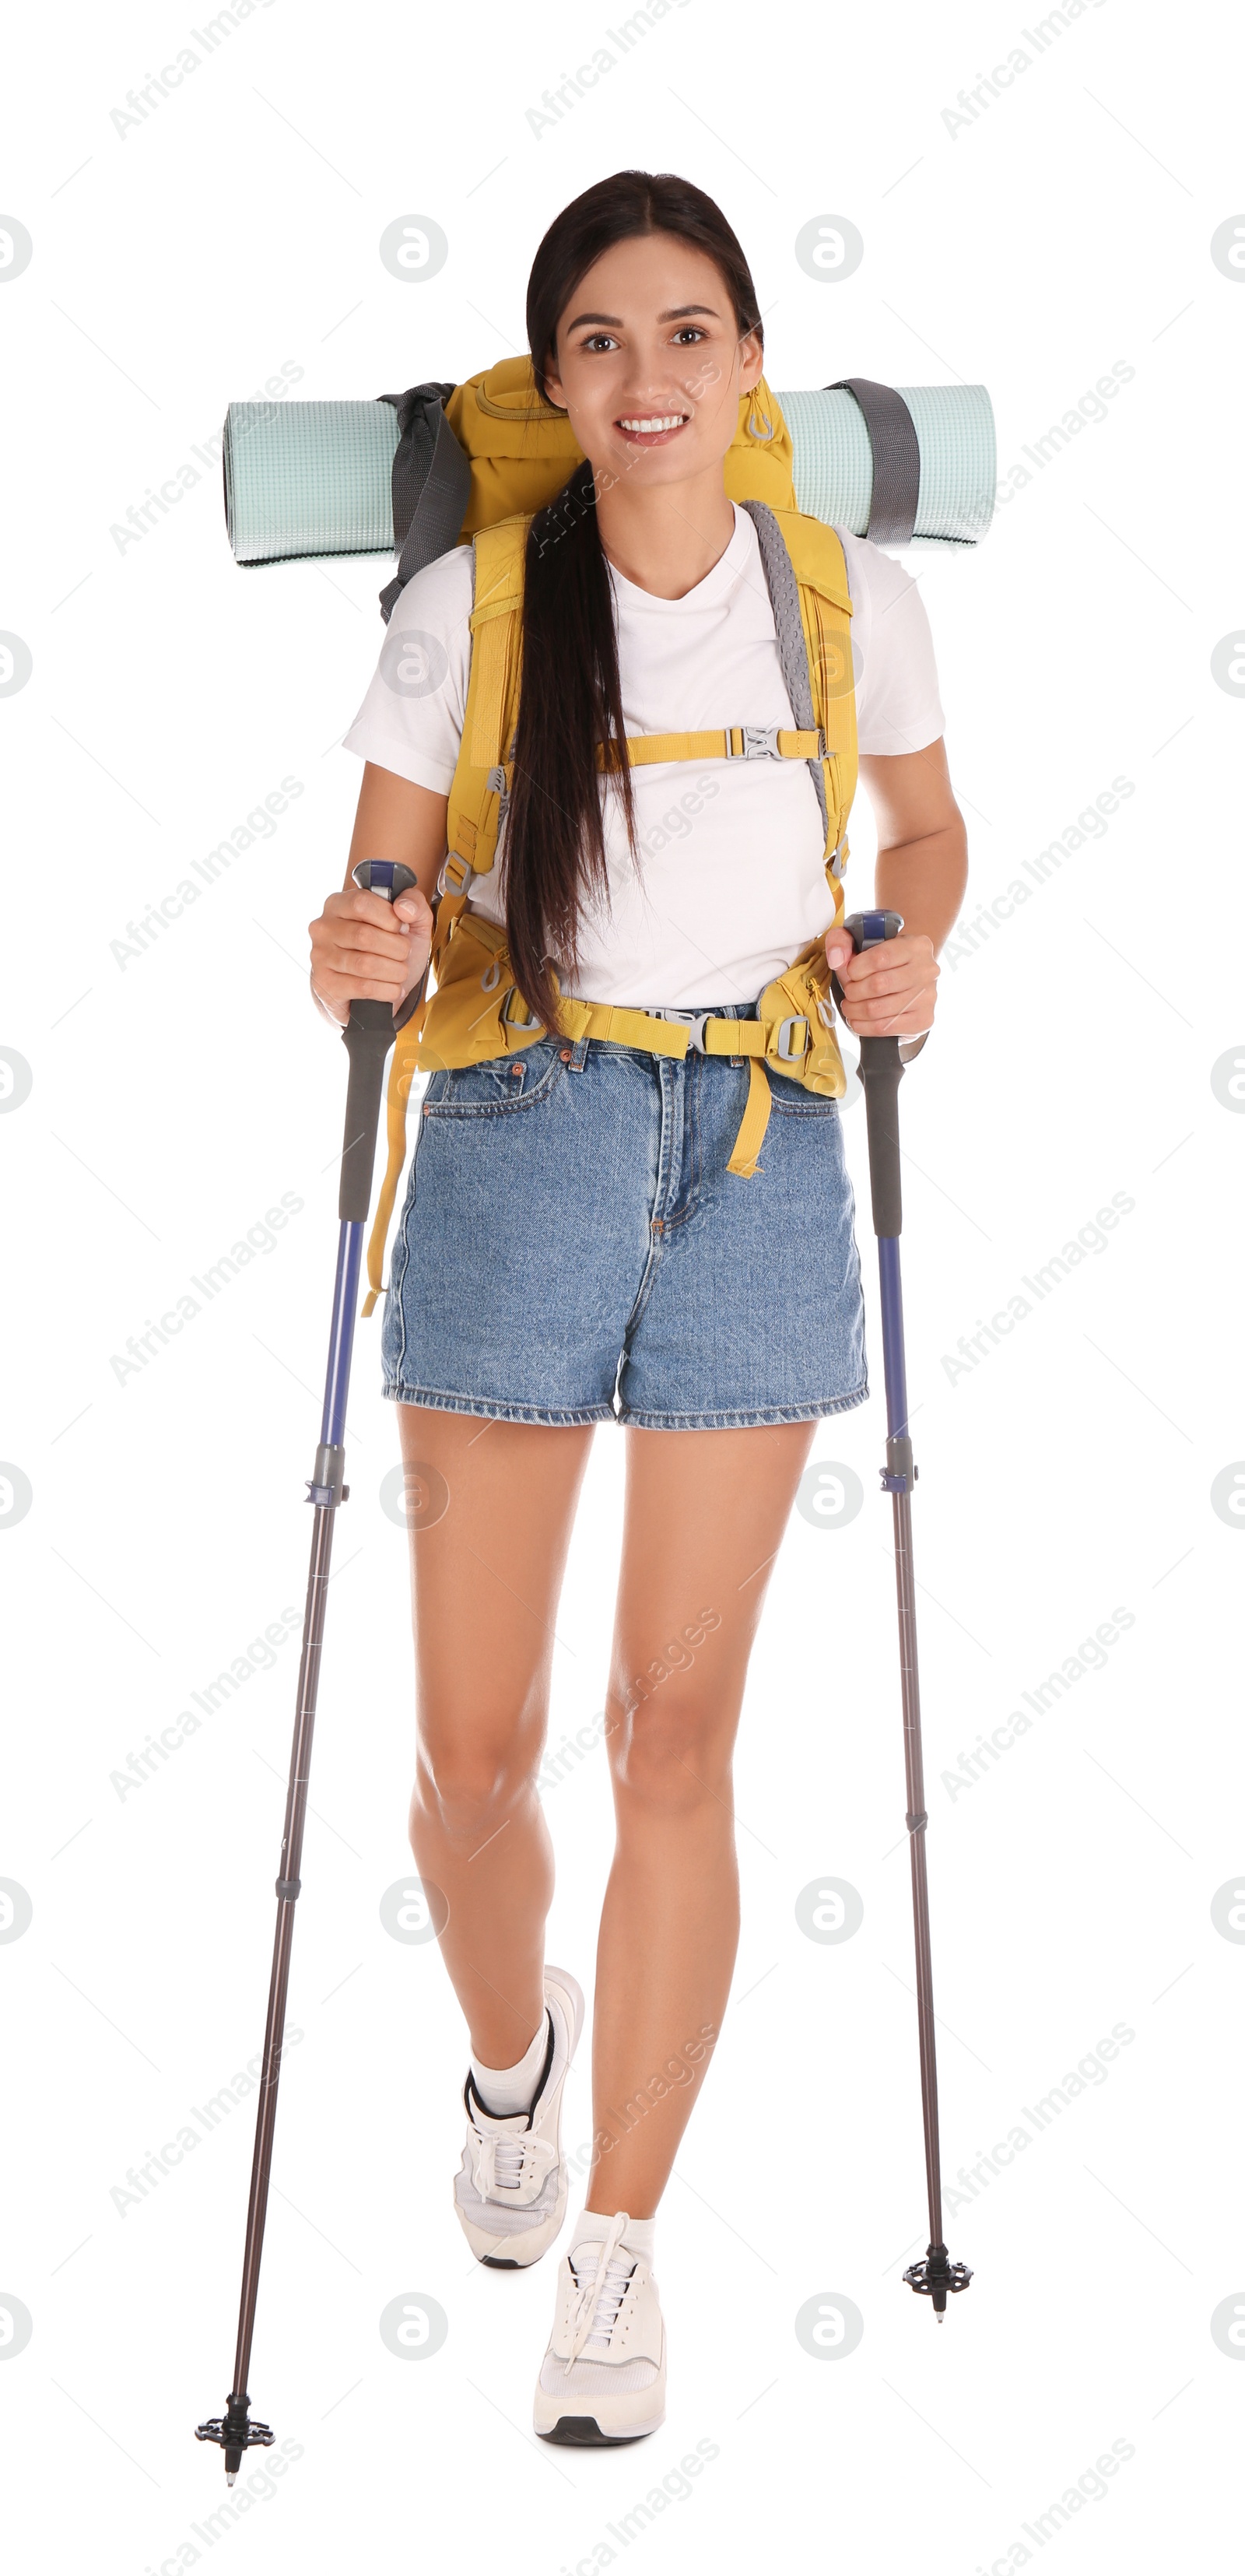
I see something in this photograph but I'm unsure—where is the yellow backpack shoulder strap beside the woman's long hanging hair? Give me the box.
[446,515,531,876]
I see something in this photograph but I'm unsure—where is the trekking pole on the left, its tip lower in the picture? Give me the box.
[196,858,423,2486]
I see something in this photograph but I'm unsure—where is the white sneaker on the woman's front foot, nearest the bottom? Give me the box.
[534,2210,665,2442]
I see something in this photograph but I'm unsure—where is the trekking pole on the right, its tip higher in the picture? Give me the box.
[833,912,972,2324]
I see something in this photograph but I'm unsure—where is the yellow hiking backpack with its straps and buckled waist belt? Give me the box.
[363,358,856,1314]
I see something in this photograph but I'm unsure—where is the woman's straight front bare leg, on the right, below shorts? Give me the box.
[587,1422,817,2218]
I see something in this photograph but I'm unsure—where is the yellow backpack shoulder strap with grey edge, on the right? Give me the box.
[740,500,856,912]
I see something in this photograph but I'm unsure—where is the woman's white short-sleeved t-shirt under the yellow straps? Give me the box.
[345,505,943,1010]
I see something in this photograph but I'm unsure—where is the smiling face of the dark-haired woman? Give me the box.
[546,232,763,484]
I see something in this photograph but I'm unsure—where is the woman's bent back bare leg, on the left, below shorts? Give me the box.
[397,1404,593,2066]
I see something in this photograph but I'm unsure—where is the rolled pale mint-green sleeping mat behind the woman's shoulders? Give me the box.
[224,376,995,564]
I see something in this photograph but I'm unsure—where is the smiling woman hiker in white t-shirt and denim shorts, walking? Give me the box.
[312,170,966,2442]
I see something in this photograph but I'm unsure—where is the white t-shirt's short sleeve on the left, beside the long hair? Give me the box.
[343,546,472,796]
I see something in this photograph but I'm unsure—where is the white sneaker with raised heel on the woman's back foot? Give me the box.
[454,1968,583,2272]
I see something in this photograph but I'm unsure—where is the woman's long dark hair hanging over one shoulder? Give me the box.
[503,170,760,1028]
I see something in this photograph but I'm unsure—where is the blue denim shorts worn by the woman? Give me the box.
[381,1013,868,1430]
